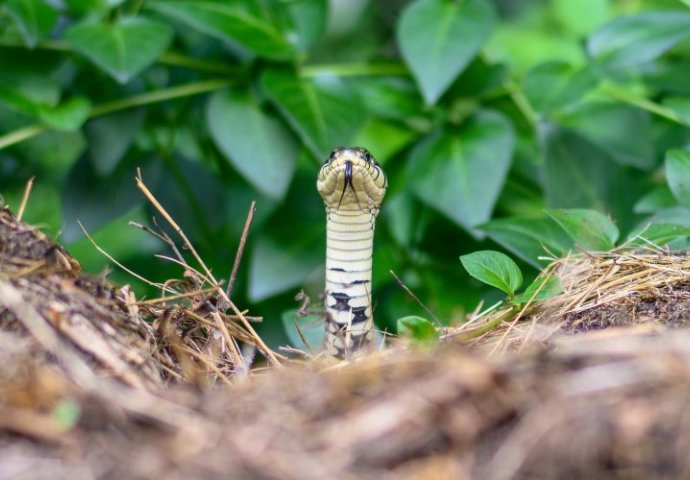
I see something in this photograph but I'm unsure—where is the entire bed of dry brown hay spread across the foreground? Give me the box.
[0,203,690,480]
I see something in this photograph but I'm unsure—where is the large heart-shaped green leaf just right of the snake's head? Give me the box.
[409,110,515,234]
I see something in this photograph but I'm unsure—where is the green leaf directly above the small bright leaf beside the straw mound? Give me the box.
[477,217,573,268]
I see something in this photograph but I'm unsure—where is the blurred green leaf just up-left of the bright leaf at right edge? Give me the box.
[559,102,655,170]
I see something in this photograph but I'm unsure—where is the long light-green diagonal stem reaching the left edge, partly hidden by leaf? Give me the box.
[0,79,232,150]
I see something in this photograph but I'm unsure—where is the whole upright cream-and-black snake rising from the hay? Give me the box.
[316,147,388,359]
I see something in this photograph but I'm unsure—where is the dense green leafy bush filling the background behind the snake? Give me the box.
[0,0,690,342]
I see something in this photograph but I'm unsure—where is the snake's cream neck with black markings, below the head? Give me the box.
[326,211,378,358]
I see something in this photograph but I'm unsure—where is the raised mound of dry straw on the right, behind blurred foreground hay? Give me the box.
[444,249,690,353]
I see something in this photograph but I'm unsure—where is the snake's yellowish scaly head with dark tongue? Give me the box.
[316,147,388,212]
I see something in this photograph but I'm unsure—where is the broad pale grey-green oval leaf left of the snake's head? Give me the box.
[206,90,297,199]
